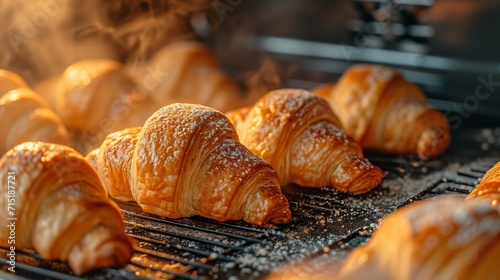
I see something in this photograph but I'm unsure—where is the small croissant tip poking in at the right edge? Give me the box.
[467,162,500,207]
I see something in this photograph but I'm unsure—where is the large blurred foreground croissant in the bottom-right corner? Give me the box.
[340,196,500,280]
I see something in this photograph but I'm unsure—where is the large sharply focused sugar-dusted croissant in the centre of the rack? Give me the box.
[87,103,291,225]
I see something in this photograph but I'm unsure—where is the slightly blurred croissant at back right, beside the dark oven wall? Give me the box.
[313,64,450,159]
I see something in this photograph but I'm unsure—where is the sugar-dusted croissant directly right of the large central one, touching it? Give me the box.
[226,89,384,193]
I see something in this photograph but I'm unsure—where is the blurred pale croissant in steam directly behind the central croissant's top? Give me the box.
[135,41,244,112]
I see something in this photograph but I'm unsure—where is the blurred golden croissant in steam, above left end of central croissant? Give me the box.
[52,59,158,133]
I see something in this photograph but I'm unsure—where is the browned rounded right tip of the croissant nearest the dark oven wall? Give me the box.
[417,128,451,159]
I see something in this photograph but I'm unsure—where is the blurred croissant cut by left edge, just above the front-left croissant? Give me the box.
[0,87,70,155]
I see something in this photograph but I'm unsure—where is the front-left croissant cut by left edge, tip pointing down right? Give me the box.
[0,142,133,275]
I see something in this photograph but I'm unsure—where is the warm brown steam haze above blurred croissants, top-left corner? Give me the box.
[0,0,213,83]
